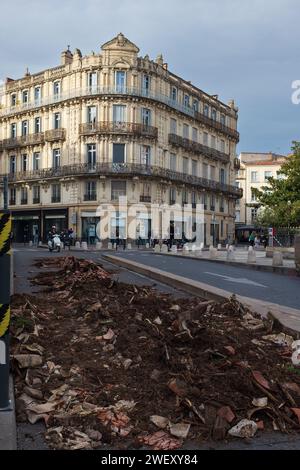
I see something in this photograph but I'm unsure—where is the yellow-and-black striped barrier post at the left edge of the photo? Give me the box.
[0,211,11,411]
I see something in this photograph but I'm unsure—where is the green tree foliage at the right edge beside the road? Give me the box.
[252,142,300,228]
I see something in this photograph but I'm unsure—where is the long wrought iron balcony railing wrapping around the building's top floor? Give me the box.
[0,86,239,141]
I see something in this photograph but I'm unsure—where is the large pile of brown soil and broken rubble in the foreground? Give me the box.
[12,257,300,450]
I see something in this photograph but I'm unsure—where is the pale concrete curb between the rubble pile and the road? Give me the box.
[102,255,300,339]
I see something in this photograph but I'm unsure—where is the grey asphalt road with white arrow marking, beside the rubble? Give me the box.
[112,251,300,309]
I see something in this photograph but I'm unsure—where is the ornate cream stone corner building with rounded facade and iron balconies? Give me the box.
[0,33,242,244]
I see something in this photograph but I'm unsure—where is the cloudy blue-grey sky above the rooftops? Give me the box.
[0,0,300,153]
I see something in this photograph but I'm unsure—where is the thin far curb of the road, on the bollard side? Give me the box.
[153,253,299,276]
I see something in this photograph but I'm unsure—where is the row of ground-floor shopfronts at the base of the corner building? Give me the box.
[12,206,234,246]
